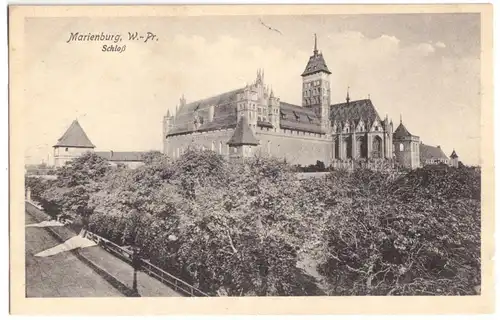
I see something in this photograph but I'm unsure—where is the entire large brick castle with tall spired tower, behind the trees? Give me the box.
[163,35,458,169]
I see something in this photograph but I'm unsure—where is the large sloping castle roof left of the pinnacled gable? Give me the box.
[168,88,244,136]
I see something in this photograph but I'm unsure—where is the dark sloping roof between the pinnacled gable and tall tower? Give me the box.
[280,102,323,133]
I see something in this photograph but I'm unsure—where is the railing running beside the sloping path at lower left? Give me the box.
[80,230,208,297]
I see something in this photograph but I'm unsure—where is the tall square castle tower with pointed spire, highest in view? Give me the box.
[302,34,331,131]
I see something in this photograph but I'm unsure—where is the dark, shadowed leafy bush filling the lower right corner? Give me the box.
[320,167,481,295]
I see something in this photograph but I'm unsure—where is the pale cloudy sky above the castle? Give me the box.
[23,13,481,164]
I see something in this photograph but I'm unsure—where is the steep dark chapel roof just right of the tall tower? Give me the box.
[330,99,380,127]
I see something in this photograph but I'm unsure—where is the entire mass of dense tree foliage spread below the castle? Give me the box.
[29,149,480,296]
